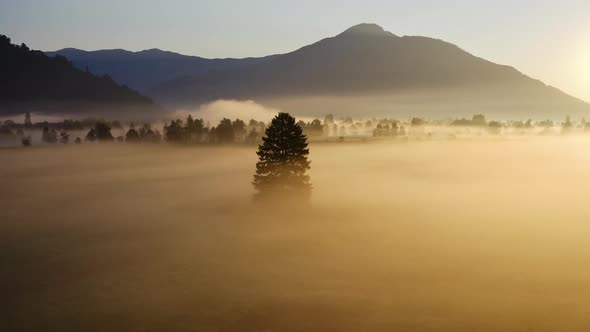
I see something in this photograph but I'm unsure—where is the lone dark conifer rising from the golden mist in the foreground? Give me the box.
[252,113,312,199]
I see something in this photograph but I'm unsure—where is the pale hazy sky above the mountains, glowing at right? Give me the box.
[0,0,590,101]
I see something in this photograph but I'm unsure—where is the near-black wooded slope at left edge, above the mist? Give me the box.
[0,35,153,105]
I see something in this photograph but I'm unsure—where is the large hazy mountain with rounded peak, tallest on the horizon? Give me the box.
[146,24,590,118]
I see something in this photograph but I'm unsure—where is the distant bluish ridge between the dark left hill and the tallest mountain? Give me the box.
[46,48,272,91]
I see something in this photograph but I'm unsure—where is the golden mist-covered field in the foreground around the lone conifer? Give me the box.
[0,137,590,332]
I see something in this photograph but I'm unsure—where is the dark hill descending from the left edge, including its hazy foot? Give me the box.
[0,35,160,115]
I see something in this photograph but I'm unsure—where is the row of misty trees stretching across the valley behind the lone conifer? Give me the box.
[0,113,590,146]
